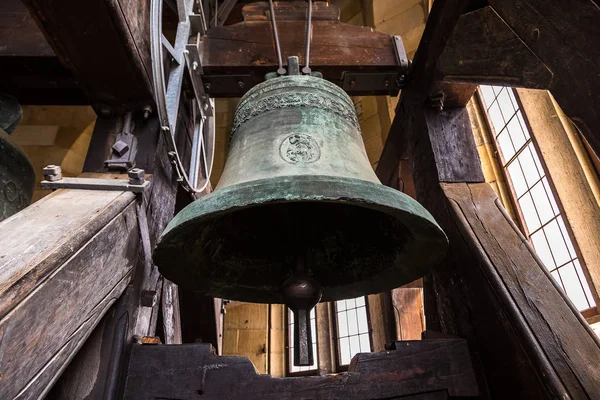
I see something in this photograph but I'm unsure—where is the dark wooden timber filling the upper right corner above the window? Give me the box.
[489,0,600,154]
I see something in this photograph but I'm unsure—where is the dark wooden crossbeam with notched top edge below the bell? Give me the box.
[124,339,477,400]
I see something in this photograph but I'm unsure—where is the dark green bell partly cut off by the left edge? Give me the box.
[0,94,35,221]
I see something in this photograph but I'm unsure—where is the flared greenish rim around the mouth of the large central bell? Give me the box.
[153,175,448,303]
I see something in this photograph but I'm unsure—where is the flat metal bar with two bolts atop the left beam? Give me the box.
[41,165,150,193]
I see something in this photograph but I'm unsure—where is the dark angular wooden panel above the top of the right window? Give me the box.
[436,6,553,88]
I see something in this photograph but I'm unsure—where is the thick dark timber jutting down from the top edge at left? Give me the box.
[23,0,152,112]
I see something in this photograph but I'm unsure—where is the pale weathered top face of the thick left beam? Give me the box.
[0,190,134,318]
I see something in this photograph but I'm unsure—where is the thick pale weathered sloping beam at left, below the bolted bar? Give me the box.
[0,186,139,399]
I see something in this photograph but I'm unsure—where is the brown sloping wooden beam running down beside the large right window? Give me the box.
[442,183,600,399]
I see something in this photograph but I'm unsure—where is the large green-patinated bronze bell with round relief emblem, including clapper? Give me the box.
[154,75,447,365]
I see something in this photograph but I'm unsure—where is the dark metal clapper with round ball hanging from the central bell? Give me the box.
[281,259,323,366]
